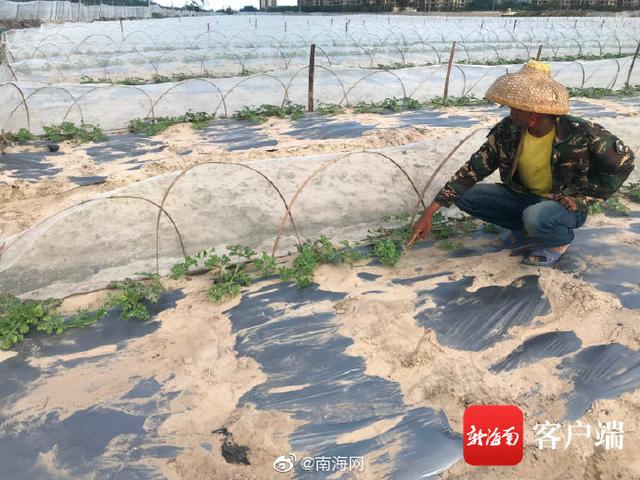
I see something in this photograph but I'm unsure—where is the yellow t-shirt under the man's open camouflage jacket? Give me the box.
[518,128,556,195]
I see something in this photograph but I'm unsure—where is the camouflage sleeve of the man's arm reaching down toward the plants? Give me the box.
[435,128,500,207]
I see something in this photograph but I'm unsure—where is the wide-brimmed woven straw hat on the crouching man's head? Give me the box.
[485,60,569,115]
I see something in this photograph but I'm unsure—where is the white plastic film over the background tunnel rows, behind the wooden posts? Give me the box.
[0,15,640,133]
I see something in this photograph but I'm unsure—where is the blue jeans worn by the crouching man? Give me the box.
[455,183,587,247]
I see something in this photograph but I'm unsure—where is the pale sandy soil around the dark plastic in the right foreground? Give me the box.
[330,258,640,480]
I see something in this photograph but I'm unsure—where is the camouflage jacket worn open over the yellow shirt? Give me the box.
[435,115,634,212]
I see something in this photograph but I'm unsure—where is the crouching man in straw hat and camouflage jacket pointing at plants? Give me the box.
[409,60,634,266]
